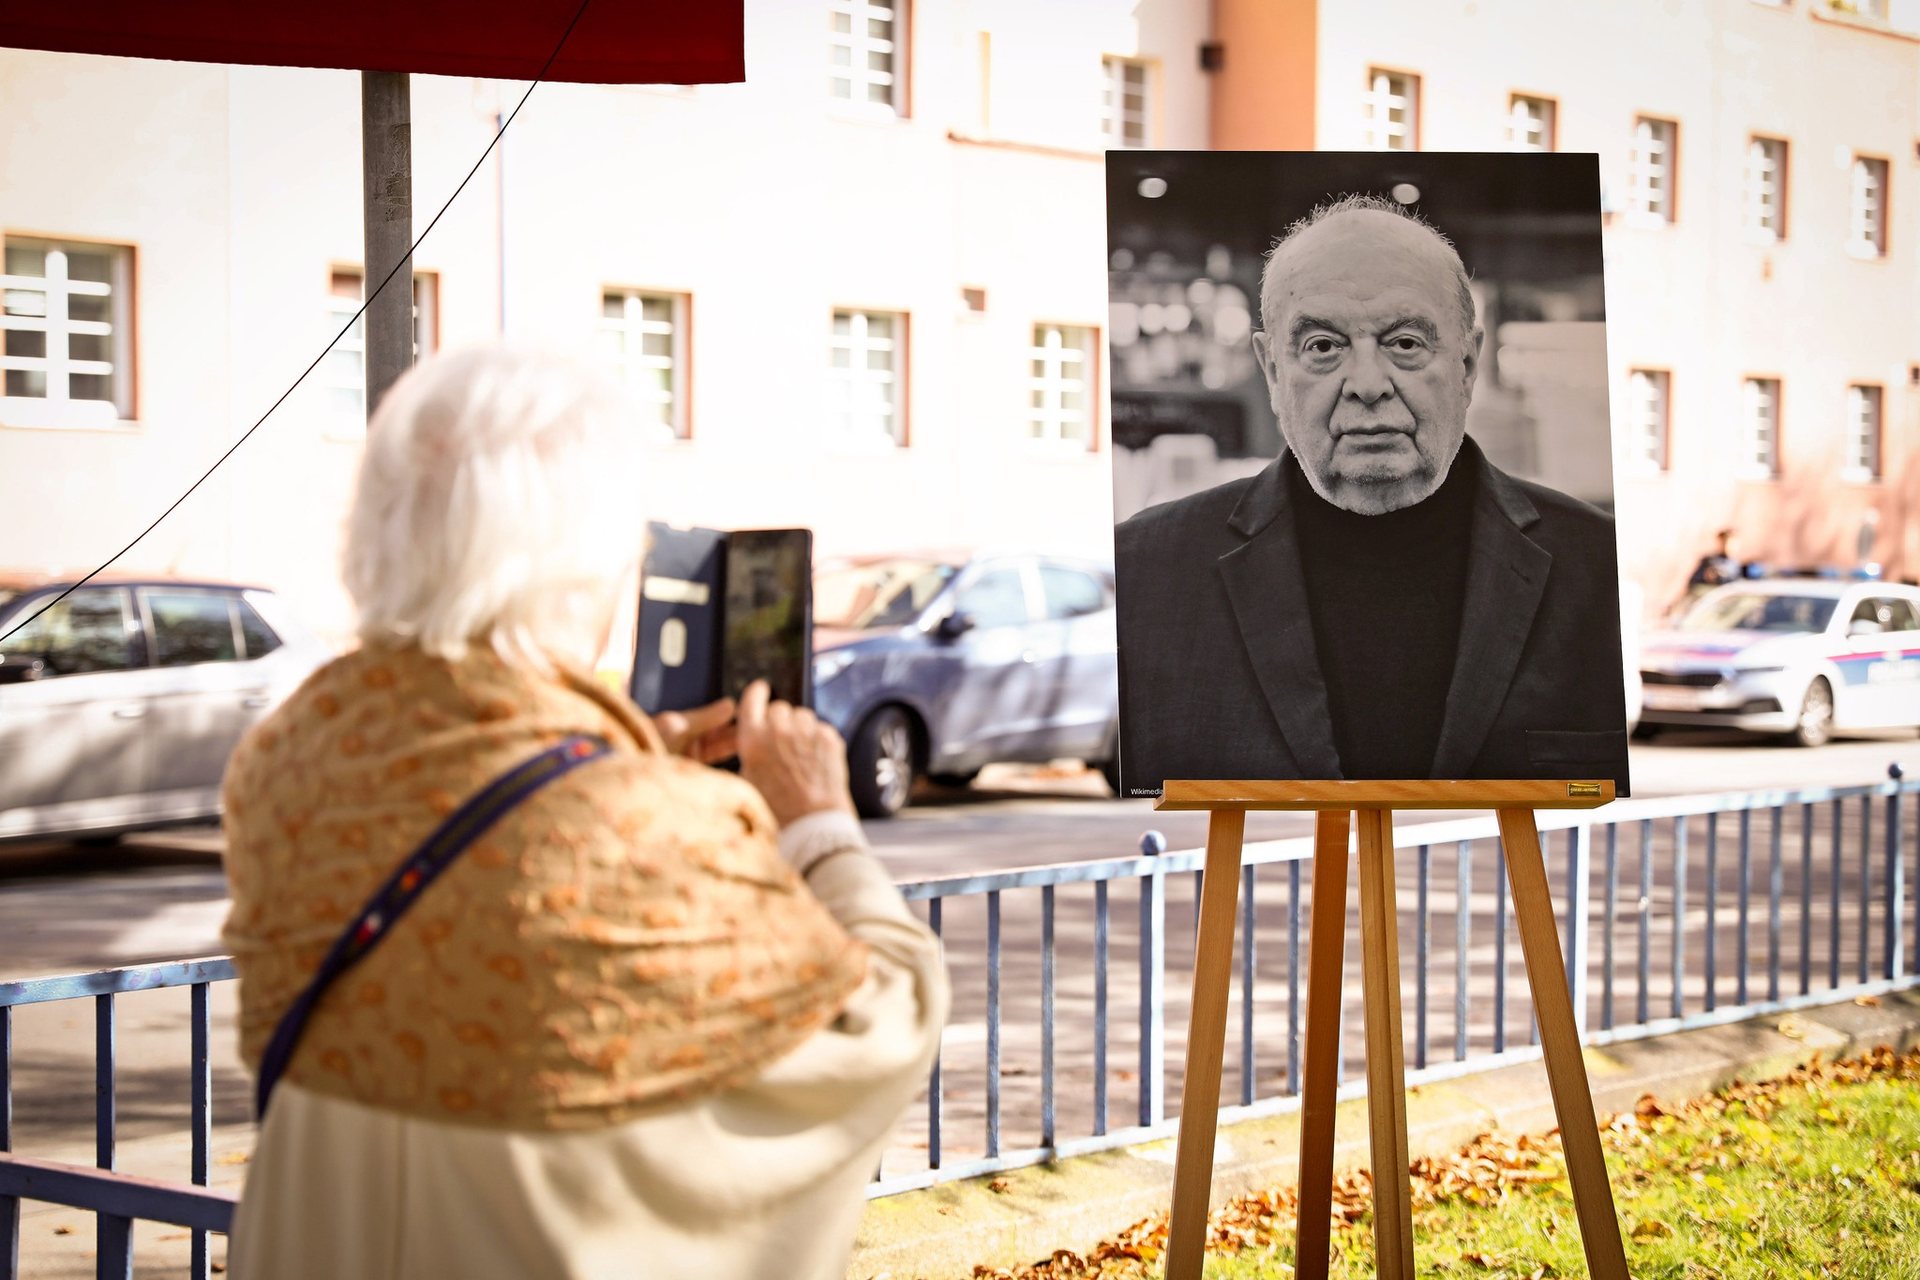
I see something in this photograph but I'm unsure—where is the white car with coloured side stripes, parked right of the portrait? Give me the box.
[1638,578,1920,747]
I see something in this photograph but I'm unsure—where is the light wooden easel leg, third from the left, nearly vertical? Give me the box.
[1359,810,1413,1280]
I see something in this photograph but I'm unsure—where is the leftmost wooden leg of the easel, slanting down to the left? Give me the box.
[1167,810,1246,1280]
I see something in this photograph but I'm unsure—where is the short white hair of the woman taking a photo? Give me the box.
[342,344,645,672]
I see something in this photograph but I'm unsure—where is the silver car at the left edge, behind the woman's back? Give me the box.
[0,576,328,839]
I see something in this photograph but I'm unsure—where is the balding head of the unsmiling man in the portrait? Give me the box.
[1254,209,1480,516]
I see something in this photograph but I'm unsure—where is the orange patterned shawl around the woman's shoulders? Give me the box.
[223,647,866,1130]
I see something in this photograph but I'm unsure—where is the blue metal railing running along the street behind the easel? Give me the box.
[0,781,1920,1280]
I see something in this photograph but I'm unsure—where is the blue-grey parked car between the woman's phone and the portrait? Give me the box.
[814,553,1119,818]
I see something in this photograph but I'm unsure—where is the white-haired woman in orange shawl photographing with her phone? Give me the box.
[225,347,947,1280]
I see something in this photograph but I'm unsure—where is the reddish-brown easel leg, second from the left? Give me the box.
[1294,810,1352,1280]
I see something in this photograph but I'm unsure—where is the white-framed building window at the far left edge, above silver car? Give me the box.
[0,236,132,435]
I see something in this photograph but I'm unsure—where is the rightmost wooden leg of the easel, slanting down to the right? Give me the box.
[1500,810,1628,1280]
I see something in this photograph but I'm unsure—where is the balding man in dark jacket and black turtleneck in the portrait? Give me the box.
[1116,196,1626,794]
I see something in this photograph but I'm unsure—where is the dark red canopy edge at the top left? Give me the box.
[0,0,745,84]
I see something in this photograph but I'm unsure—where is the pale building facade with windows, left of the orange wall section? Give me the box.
[0,0,1208,637]
